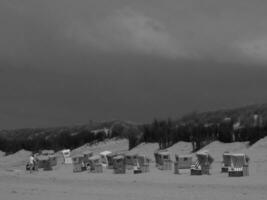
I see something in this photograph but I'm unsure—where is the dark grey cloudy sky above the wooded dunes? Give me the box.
[0,0,267,129]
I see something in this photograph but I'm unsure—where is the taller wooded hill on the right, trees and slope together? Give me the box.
[140,104,267,151]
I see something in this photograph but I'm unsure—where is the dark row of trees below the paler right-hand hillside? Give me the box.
[142,115,267,151]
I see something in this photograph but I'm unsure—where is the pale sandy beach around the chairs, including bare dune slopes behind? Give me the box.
[0,138,267,200]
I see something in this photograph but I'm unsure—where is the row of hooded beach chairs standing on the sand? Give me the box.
[26,150,249,177]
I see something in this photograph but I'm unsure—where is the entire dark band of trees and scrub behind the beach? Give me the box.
[0,104,267,153]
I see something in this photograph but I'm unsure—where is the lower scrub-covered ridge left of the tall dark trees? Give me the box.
[0,120,138,153]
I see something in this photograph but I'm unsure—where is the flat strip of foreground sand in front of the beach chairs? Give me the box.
[0,167,267,200]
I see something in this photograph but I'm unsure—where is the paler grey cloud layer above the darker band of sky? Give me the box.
[0,0,267,64]
